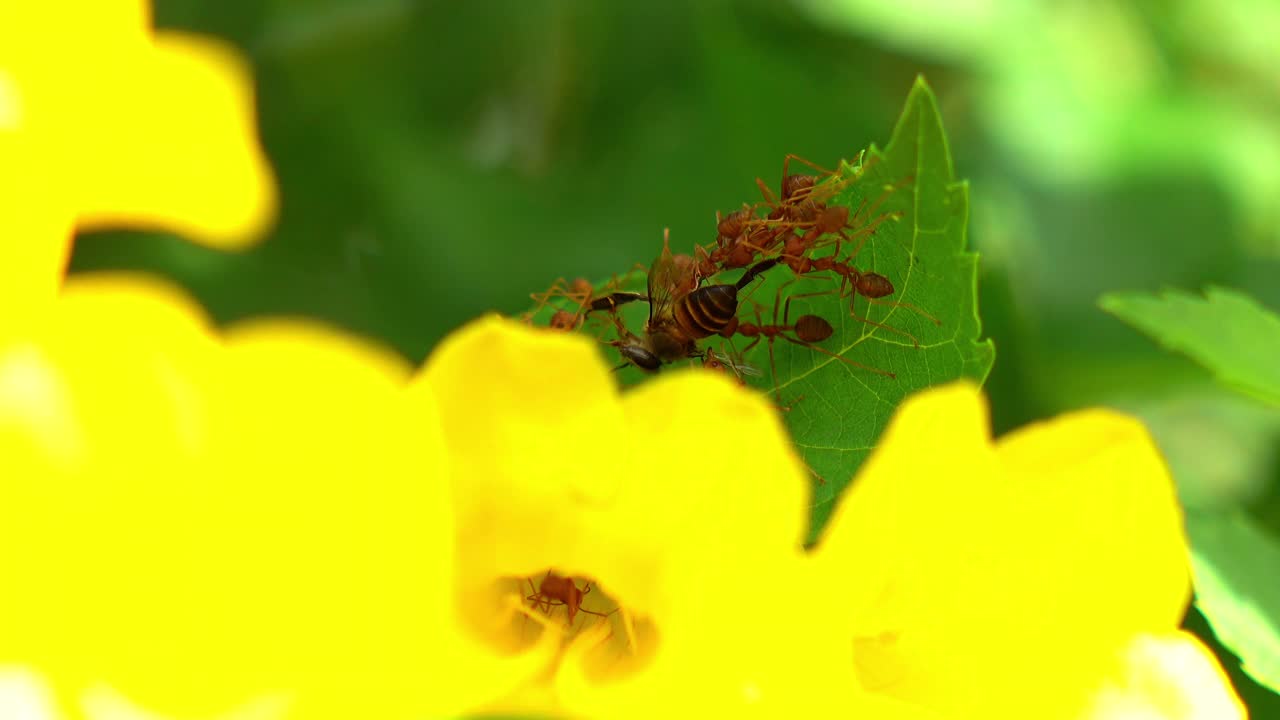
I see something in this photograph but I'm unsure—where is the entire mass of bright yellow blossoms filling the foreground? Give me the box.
[0,1,1243,719]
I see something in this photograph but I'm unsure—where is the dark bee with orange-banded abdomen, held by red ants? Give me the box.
[591,232,780,372]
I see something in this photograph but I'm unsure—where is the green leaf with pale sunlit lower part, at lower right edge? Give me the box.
[1187,514,1280,691]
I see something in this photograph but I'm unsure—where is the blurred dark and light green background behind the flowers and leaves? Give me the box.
[73,0,1280,717]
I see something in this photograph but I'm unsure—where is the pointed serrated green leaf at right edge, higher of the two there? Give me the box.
[1100,287,1280,404]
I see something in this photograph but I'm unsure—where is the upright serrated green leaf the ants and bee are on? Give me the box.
[524,78,995,541]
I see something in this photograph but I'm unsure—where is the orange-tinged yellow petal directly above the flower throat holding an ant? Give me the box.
[424,316,622,585]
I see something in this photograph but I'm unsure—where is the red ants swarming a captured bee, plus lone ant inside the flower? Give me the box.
[524,155,941,625]
